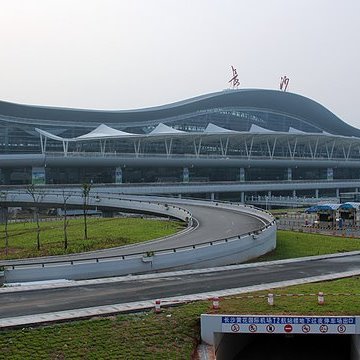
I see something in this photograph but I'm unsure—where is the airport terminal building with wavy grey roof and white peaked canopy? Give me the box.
[0,89,360,196]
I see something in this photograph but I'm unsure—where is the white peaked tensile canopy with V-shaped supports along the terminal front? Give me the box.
[36,123,360,159]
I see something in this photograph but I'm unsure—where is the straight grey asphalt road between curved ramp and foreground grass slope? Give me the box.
[0,255,360,318]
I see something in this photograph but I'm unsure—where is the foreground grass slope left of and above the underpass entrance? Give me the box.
[0,277,360,360]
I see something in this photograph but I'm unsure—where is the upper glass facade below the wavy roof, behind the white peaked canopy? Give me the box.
[0,108,330,154]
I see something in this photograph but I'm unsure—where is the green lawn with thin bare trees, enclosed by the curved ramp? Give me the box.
[0,217,185,259]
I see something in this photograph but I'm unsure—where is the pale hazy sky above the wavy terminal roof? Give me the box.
[0,0,360,127]
